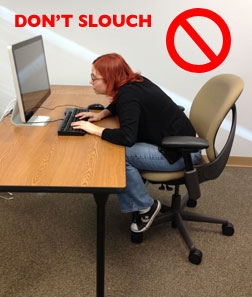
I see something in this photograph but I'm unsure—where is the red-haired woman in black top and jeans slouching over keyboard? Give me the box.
[72,54,200,232]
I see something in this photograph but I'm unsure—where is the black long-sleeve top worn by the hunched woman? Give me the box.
[102,77,195,146]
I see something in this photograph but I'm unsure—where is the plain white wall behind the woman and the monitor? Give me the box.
[0,0,252,156]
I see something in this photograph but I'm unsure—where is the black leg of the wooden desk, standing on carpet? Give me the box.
[94,194,109,297]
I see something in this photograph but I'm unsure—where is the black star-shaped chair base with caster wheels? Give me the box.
[131,186,234,265]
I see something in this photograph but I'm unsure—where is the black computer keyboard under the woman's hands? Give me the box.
[58,108,89,136]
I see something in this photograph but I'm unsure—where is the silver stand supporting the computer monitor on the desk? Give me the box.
[11,102,50,127]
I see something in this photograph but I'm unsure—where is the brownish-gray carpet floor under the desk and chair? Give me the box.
[0,168,252,297]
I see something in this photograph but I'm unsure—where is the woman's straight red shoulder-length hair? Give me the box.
[93,53,143,101]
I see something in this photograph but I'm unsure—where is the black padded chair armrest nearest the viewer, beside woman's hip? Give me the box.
[160,136,209,151]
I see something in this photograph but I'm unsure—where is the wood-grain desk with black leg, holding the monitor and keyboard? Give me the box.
[0,86,126,296]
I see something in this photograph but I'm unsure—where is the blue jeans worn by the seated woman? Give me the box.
[118,142,201,213]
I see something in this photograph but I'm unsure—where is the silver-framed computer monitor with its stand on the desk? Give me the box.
[8,35,51,126]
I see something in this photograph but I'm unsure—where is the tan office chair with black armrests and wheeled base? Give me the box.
[131,74,244,264]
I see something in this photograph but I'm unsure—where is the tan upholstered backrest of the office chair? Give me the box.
[190,74,244,162]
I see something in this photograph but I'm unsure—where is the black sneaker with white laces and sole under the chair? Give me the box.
[130,200,161,233]
